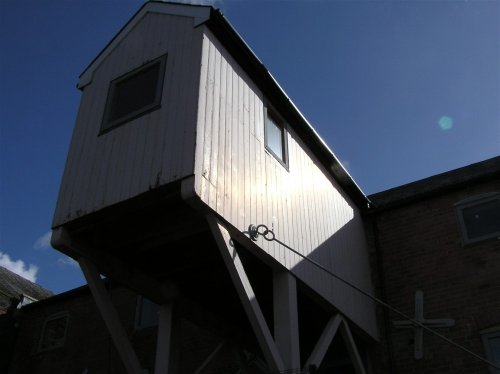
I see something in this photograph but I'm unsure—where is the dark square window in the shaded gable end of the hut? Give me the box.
[101,55,167,133]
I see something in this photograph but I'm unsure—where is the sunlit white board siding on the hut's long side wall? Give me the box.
[195,27,377,336]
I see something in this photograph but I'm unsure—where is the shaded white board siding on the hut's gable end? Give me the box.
[53,12,202,226]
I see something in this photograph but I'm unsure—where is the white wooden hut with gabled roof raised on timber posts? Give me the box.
[53,2,378,373]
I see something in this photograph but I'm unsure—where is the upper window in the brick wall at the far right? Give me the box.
[455,192,500,245]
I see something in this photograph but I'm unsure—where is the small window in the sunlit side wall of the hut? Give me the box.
[264,107,288,168]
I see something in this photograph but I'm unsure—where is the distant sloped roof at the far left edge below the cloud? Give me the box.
[0,266,54,314]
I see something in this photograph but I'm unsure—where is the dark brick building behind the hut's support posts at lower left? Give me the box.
[2,281,270,374]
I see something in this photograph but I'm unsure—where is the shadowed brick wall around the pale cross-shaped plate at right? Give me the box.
[367,181,500,374]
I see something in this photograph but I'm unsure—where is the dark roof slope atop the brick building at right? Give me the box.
[368,156,500,210]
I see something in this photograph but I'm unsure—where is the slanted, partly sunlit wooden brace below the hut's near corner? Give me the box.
[207,215,285,372]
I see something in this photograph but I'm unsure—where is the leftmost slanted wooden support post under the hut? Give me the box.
[78,258,142,374]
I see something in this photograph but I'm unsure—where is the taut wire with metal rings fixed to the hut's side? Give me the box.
[248,224,500,369]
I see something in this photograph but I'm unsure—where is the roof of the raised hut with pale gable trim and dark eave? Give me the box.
[77,1,370,209]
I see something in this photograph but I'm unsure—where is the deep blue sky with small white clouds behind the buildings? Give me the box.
[0,0,500,292]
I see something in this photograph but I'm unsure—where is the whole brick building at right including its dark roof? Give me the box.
[367,157,500,374]
